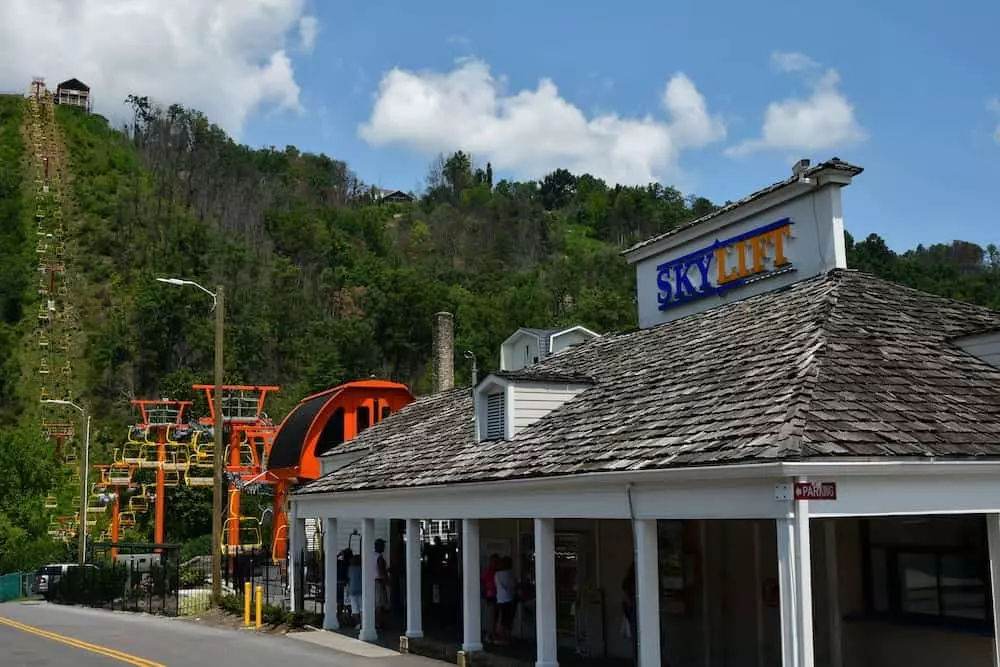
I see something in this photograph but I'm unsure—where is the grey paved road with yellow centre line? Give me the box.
[0,602,443,667]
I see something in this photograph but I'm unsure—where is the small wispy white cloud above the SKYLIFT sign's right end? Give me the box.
[726,53,867,155]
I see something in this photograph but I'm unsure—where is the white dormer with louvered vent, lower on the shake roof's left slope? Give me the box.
[473,371,593,442]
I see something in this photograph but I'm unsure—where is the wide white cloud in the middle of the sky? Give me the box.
[358,59,726,184]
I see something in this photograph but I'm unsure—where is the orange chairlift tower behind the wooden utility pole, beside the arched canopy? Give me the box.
[188,384,280,556]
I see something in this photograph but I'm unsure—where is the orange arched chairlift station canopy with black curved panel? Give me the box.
[267,380,414,480]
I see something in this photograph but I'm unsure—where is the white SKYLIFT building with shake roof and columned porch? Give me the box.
[292,159,1000,667]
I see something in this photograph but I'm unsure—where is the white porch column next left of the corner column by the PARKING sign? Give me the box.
[634,519,662,667]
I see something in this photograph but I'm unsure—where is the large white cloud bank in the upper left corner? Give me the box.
[0,0,316,136]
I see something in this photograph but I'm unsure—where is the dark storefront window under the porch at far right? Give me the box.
[864,517,990,624]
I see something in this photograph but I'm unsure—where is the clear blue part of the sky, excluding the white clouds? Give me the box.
[243,0,1000,249]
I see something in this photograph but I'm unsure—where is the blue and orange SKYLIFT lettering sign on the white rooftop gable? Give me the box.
[656,218,792,310]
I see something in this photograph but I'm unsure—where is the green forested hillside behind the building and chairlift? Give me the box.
[0,97,1000,571]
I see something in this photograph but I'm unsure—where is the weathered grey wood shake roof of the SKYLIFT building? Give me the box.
[299,270,1000,493]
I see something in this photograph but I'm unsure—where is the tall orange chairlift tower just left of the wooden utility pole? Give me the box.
[129,398,191,544]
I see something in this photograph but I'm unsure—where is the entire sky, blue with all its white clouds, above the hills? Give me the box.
[0,0,1000,250]
